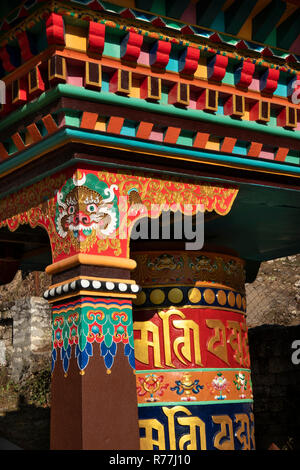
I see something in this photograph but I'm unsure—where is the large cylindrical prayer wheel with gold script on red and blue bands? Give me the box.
[132,251,255,450]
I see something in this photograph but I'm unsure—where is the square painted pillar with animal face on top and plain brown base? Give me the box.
[44,170,139,450]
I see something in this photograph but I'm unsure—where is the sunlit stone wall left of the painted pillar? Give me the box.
[0,297,51,381]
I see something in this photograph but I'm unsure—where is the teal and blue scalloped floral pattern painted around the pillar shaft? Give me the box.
[52,298,135,373]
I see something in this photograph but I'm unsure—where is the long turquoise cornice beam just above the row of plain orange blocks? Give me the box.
[0,84,300,145]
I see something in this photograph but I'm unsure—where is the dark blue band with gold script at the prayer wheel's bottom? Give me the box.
[139,404,255,450]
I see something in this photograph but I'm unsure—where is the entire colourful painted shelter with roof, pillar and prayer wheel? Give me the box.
[0,0,300,451]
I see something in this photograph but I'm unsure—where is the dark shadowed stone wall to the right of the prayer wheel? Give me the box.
[249,325,300,450]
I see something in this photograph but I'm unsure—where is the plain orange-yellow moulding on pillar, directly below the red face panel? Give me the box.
[46,253,136,274]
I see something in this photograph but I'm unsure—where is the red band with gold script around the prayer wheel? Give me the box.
[133,308,250,370]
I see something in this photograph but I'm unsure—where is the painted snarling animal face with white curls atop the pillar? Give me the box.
[56,172,118,247]
